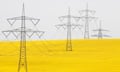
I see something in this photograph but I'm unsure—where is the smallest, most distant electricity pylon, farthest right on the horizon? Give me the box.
[92,21,110,39]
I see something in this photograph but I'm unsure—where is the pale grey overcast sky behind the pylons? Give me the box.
[0,0,120,39]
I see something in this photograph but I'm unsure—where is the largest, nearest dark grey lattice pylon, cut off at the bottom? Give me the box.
[3,4,44,72]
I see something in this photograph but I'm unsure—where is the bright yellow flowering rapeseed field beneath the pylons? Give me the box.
[0,39,120,72]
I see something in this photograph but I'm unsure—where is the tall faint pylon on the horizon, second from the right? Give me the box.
[80,4,97,39]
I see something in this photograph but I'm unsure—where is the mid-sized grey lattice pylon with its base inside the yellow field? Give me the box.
[56,8,81,51]
